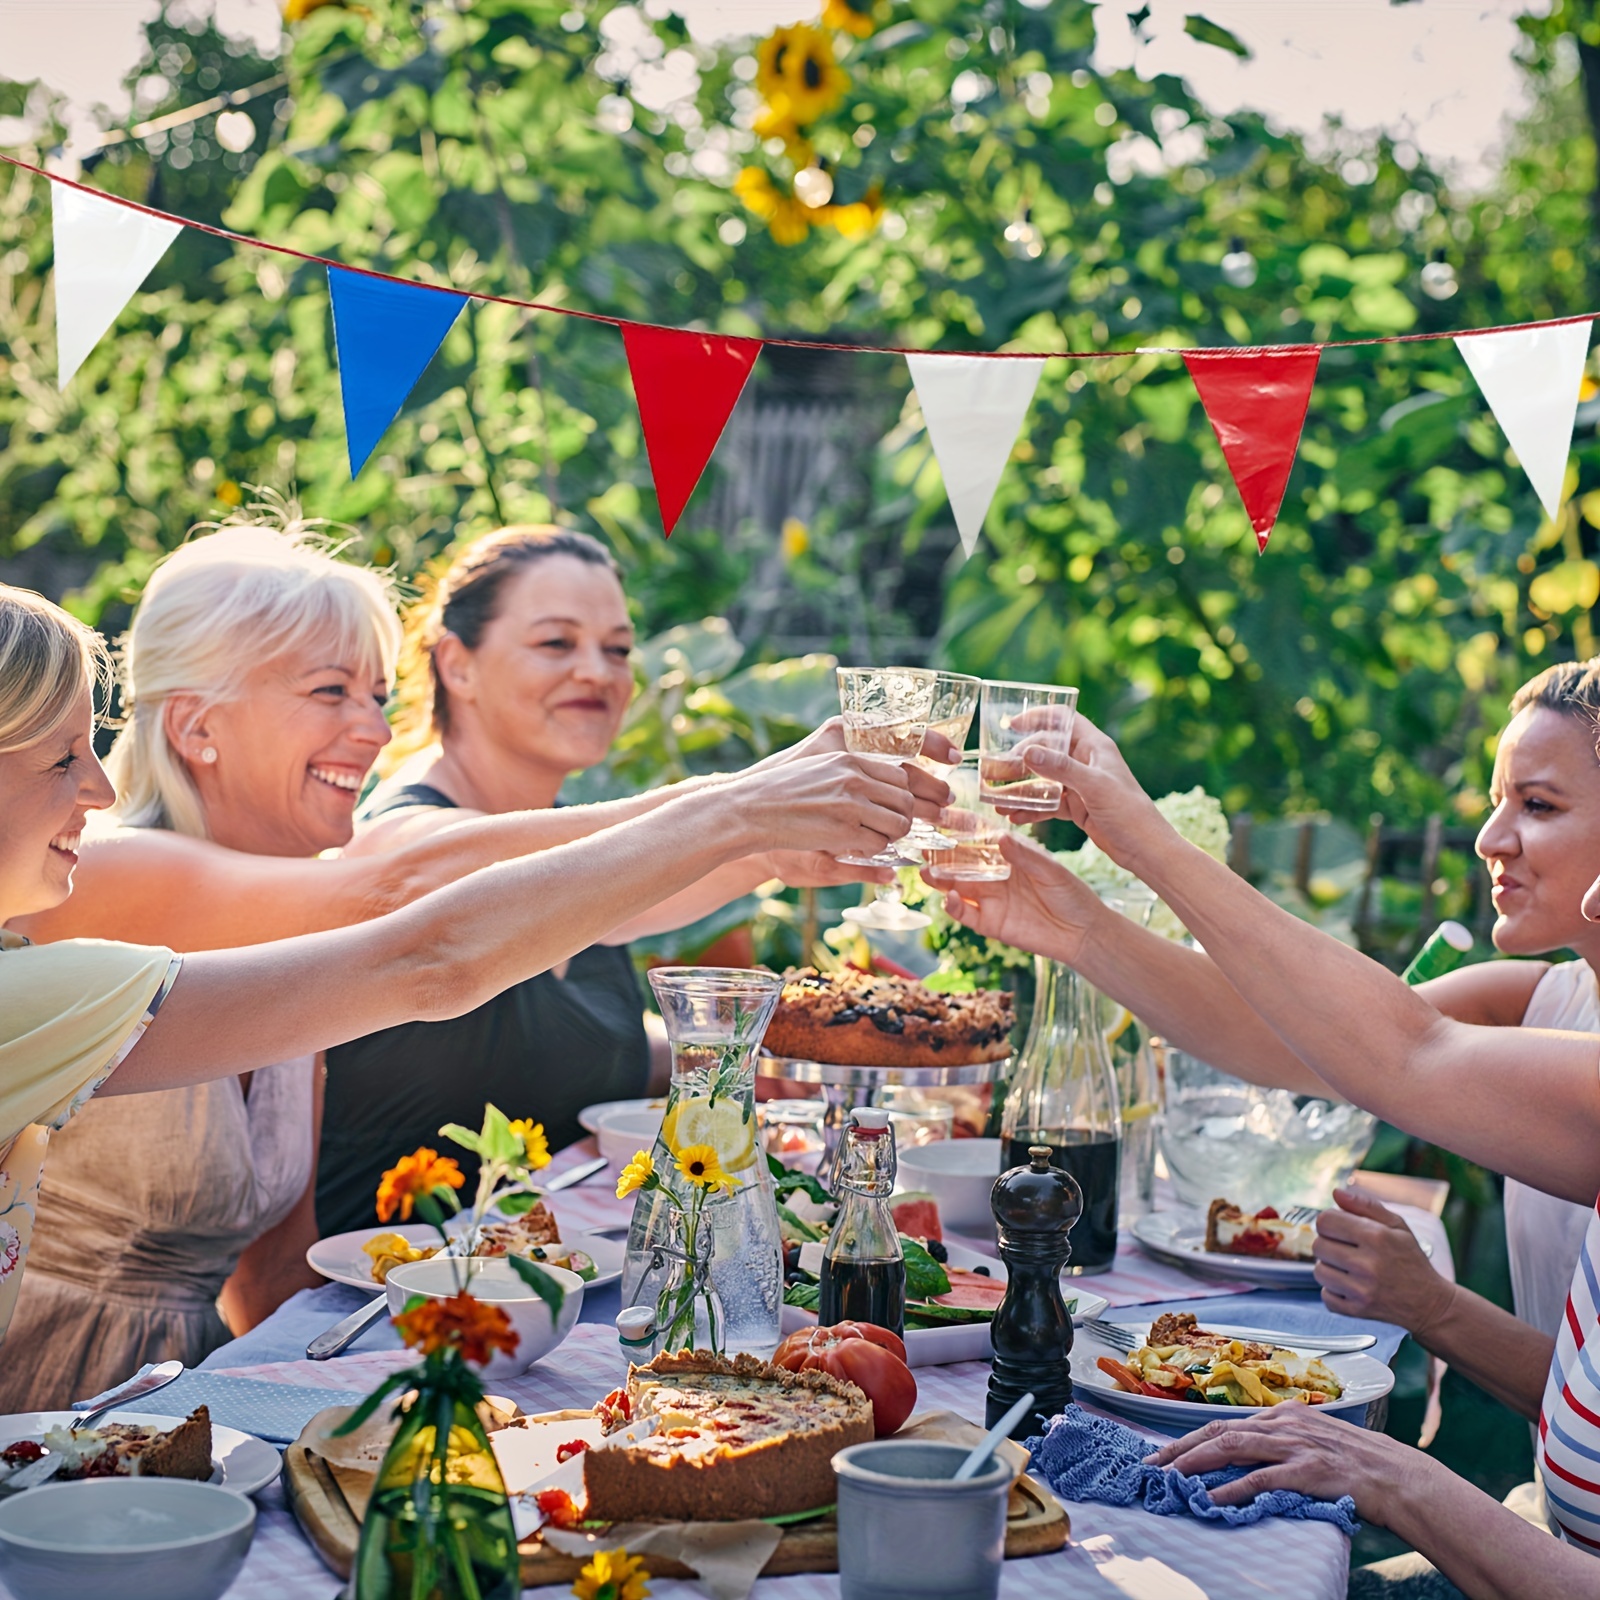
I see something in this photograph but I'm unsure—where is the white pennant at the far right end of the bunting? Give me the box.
[1456,317,1594,522]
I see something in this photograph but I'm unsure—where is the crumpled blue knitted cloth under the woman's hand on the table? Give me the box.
[1026,1405,1360,1534]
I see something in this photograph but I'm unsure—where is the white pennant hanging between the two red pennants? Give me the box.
[906,355,1045,555]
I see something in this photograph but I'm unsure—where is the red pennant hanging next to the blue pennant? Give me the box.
[622,322,762,539]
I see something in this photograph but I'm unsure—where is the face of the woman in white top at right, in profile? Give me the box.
[1477,706,1600,955]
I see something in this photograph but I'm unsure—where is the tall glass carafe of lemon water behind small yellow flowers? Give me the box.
[622,966,784,1360]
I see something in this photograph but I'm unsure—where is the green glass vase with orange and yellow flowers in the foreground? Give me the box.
[336,1106,565,1600]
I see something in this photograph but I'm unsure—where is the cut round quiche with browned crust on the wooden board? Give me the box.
[582,1350,874,1522]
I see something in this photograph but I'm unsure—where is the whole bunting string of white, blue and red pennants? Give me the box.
[0,154,1595,557]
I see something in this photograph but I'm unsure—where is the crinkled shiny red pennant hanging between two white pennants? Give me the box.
[1184,344,1322,550]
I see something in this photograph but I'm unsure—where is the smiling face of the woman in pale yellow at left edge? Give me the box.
[0,686,117,923]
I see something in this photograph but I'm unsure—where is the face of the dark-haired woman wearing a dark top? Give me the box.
[435,555,634,792]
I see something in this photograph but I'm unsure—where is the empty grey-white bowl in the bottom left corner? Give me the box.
[0,1478,256,1600]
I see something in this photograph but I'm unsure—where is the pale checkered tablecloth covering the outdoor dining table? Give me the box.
[0,1141,1448,1600]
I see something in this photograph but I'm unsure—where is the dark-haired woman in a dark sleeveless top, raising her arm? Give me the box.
[317,528,861,1234]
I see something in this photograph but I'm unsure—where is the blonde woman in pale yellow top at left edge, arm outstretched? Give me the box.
[0,586,946,1376]
